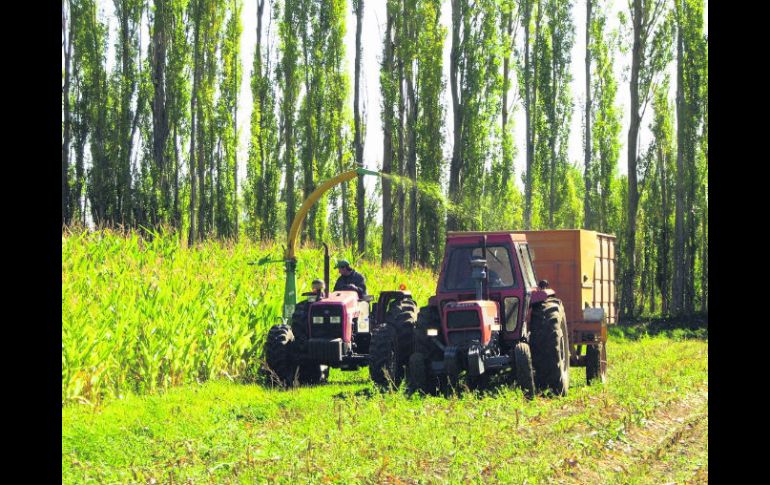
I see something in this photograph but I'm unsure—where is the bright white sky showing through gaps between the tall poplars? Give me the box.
[93,0,708,213]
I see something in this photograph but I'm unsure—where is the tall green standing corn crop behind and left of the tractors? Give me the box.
[62,230,436,405]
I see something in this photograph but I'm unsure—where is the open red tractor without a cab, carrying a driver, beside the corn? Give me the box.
[265,248,417,387]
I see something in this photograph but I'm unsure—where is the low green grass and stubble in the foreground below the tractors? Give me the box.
[62,330,708,483]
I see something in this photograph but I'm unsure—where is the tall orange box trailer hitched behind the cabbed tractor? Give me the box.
[516,229,617,381]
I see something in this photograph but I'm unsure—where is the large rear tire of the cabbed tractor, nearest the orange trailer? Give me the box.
[530,298,569,396]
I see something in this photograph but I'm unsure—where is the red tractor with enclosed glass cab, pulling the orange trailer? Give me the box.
[407,232,570,396]
